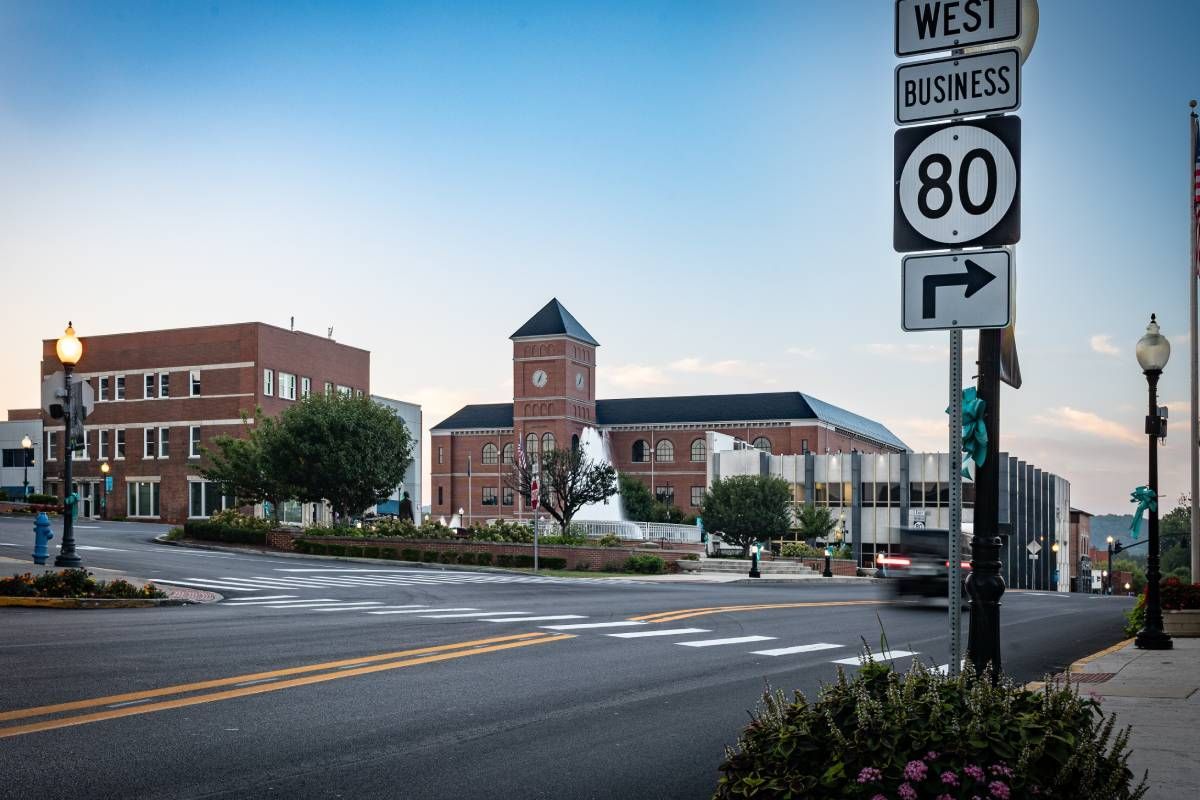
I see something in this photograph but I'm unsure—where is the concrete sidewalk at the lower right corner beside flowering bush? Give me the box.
[1072,638,1200,800]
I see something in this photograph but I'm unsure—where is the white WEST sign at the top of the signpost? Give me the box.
[895,0,1021,56]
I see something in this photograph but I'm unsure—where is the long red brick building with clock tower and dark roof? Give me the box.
[430,300,907,519]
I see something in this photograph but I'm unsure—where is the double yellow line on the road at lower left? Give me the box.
[0,633,574,739]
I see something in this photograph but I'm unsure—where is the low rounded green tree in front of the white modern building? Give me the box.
[701,475,792,555]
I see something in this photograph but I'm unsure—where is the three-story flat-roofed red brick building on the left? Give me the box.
[34,323,371,523]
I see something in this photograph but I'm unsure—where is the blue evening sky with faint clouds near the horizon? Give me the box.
[0,0,1200,513]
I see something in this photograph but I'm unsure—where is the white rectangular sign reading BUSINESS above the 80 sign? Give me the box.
[895,49,1021,125]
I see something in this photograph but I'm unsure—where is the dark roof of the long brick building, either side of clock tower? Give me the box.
[433,392,908,450]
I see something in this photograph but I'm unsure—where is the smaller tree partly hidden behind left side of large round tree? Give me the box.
[199,409,295,525]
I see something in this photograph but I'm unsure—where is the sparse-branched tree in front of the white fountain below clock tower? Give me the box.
[504,447,617,535]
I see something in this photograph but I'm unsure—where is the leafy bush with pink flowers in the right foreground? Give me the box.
[715,660,1146,800]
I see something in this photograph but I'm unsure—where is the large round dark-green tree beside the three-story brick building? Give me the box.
[265,395,413,522]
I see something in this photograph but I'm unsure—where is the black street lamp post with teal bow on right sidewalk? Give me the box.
[1132,314,1171,650]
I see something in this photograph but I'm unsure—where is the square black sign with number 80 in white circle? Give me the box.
[892,116,1021,253]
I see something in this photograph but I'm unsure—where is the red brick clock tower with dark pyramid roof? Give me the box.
[509,299,600,462]
